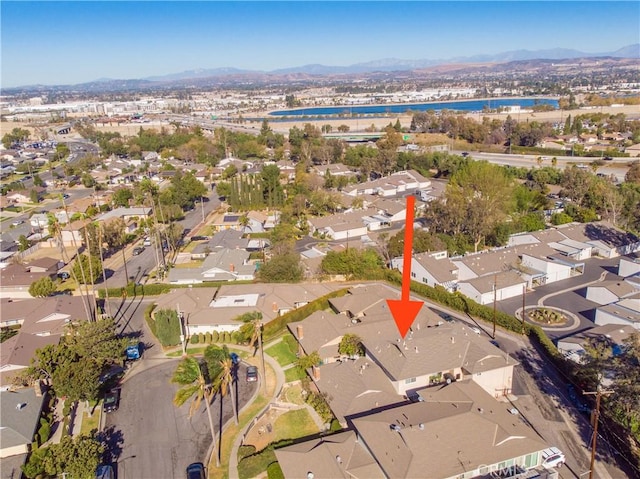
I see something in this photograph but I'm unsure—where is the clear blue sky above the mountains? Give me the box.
[0,0,640,88]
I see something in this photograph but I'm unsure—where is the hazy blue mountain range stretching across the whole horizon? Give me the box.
[3,43,640,94]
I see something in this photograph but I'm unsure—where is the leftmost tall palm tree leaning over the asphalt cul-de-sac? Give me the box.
[171,357,220,467]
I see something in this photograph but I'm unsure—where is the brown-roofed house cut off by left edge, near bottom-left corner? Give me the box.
[0,388,46,458]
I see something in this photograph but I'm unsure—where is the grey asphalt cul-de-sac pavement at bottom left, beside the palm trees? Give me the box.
[105,359,259,479]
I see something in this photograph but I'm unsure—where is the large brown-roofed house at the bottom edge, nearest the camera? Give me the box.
[275,381,548,479]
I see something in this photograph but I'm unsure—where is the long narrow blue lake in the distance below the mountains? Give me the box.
[269,98,558,116]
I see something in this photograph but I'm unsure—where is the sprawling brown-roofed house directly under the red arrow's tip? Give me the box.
[289,284,516,397]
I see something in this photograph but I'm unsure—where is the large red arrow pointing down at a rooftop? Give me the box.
[387,196,424,338]
